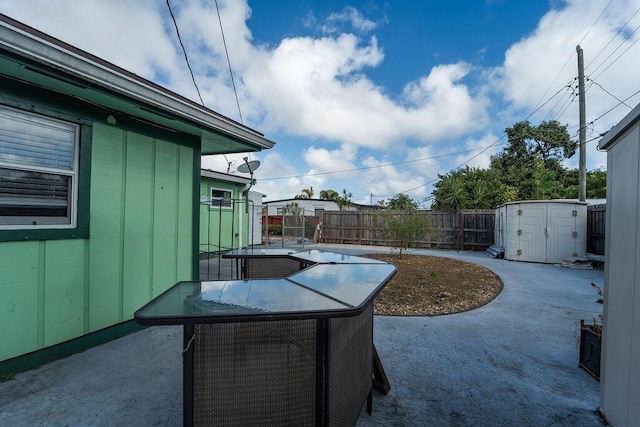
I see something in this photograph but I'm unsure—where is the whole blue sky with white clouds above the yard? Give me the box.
[5,0,640,206]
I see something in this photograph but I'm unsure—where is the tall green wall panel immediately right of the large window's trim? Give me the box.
[89,125,125,331]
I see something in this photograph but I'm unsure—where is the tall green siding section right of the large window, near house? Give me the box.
[89,125,194,332]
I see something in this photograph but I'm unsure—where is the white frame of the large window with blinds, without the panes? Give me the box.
[0,105,80,230]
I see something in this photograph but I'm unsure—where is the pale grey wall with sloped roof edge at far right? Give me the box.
[599,104,640,427]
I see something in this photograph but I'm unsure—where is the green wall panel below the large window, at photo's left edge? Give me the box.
[0,242,42,360]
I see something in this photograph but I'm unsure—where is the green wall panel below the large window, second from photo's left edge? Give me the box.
[43,240,85,347]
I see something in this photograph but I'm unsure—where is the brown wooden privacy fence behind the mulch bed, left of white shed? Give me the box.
[322,209,495,251]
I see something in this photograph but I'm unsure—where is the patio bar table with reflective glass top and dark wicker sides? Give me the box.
[135,251,396,426]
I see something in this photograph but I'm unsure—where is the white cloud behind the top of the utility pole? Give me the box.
[498,0,640,130]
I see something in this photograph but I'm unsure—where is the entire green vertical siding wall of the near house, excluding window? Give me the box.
[0,124,198,361]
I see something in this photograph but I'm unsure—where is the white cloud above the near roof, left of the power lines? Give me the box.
[2,0,183,84]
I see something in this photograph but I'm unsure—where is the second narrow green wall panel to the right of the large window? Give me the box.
[122,134,155,319]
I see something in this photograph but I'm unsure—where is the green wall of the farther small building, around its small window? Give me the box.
[200,177,248,252]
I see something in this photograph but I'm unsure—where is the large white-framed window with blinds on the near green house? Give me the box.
[0,106,80,229]
